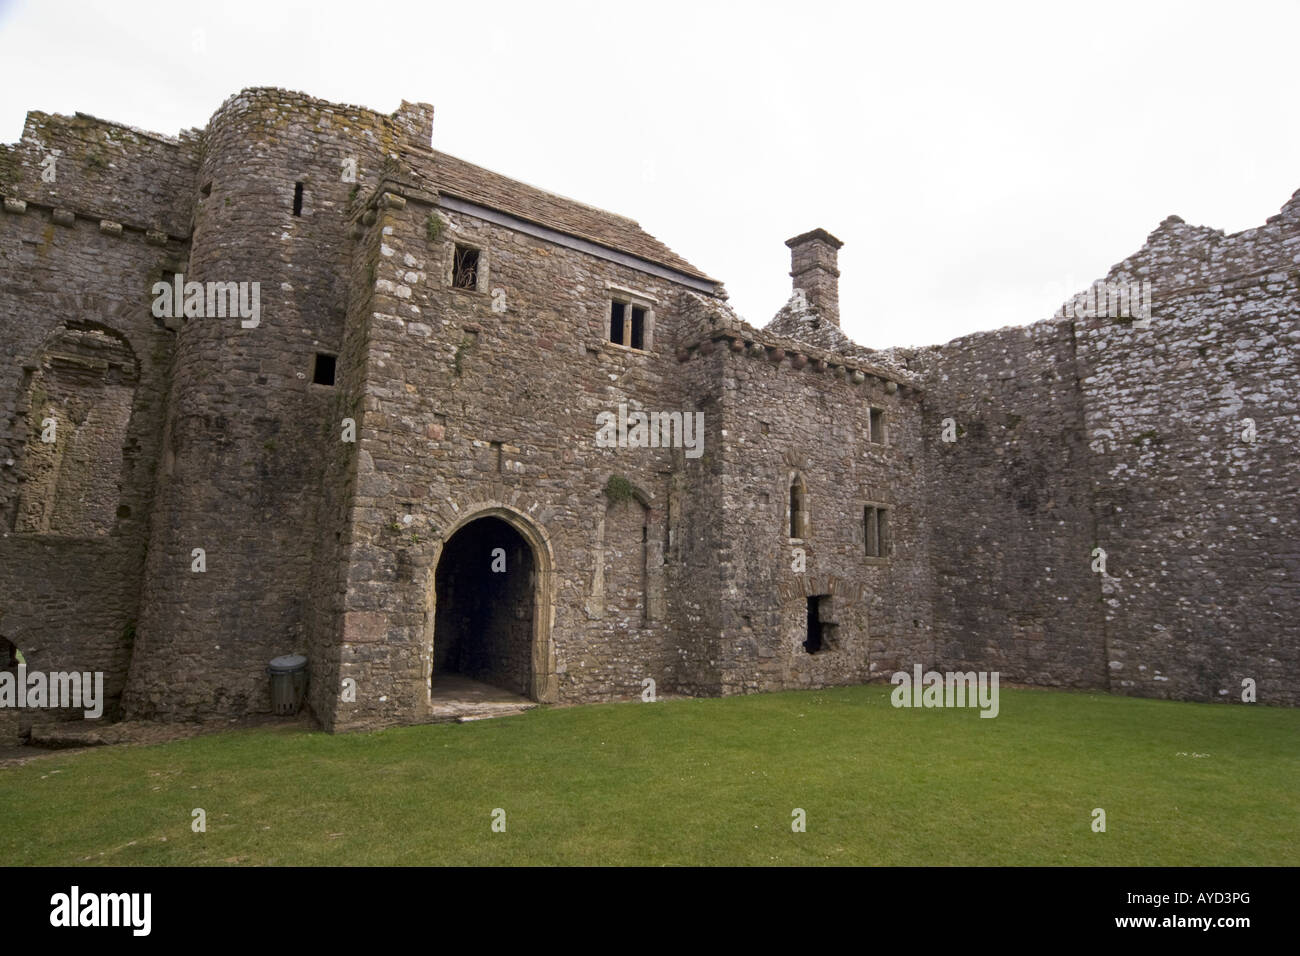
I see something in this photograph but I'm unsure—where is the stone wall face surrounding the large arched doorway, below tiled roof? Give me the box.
[313,167,709,726]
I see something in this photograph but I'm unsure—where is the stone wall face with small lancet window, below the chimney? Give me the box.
[683,300,932,693]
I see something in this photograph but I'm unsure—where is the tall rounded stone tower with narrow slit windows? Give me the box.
[127,88,410,718]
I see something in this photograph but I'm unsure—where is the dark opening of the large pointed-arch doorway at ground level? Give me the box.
[432,515,538,700]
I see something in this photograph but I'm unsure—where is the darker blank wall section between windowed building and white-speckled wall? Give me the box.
[896,320,1106,687]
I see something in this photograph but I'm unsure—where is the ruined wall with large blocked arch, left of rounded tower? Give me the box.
[0,112,198,717]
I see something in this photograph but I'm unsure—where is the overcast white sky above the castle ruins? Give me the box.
[0,0,1300,347]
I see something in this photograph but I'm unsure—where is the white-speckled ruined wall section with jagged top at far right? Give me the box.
[1079,194,1300,705]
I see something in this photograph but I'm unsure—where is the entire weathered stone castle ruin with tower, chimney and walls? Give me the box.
[0,88,1300,728]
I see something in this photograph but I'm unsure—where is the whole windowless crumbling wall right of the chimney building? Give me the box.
[893,198,1300,704]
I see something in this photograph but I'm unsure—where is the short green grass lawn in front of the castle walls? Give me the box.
[0,685,1300,866]
